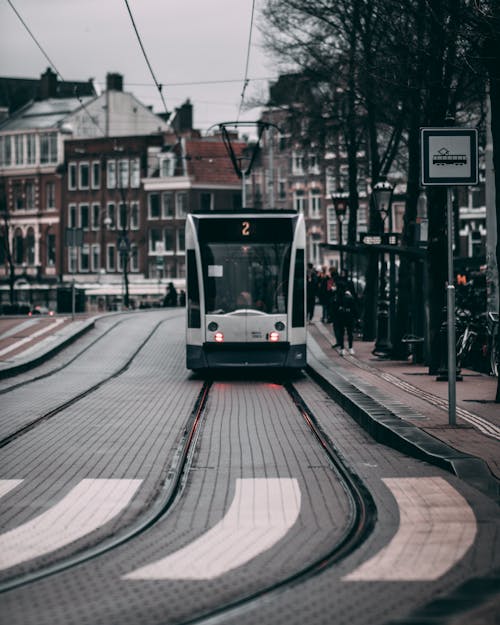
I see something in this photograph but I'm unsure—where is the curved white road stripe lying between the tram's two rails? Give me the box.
[124,478,300,580]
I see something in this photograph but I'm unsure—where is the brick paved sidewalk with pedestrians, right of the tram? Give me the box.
[309,321,500,479]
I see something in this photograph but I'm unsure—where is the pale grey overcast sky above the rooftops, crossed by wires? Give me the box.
[0,0,278,130]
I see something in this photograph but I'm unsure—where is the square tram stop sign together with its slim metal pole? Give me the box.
[420,127,478,425]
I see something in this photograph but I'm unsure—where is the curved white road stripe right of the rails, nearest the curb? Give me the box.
[342,477,477,582]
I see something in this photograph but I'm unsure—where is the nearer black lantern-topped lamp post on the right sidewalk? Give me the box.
[372,180,394,358]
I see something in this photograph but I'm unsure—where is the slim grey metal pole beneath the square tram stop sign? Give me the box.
[446,187,457,425]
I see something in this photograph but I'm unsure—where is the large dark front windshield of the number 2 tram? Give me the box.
[201,242,291,315]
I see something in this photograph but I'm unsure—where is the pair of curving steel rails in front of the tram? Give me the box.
[0,370,376,625]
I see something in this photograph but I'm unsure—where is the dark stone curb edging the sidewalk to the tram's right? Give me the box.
[306,365,500,504]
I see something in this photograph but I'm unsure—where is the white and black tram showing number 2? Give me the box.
[186,209,306,371]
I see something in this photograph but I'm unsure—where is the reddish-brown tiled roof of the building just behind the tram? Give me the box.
[184,137,246,186]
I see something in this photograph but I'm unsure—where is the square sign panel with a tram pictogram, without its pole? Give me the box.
[420,128,478,186]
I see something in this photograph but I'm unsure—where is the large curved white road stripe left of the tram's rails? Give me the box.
[0,479,141,569]
